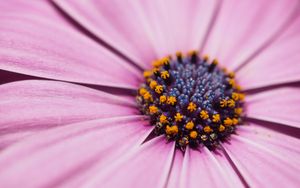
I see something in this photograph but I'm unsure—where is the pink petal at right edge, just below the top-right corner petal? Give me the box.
[236,16,300,90]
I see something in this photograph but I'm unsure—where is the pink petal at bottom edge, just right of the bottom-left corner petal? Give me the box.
[82,136,175,188]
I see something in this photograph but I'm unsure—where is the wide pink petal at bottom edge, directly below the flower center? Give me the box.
[180,147,243,188]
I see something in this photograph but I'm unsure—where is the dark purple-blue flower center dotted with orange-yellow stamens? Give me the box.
[137,51,244,150]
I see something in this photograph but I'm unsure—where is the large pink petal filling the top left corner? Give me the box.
[0,0,141,88]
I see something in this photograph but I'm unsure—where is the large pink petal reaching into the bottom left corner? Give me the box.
[0,116,152,187]
